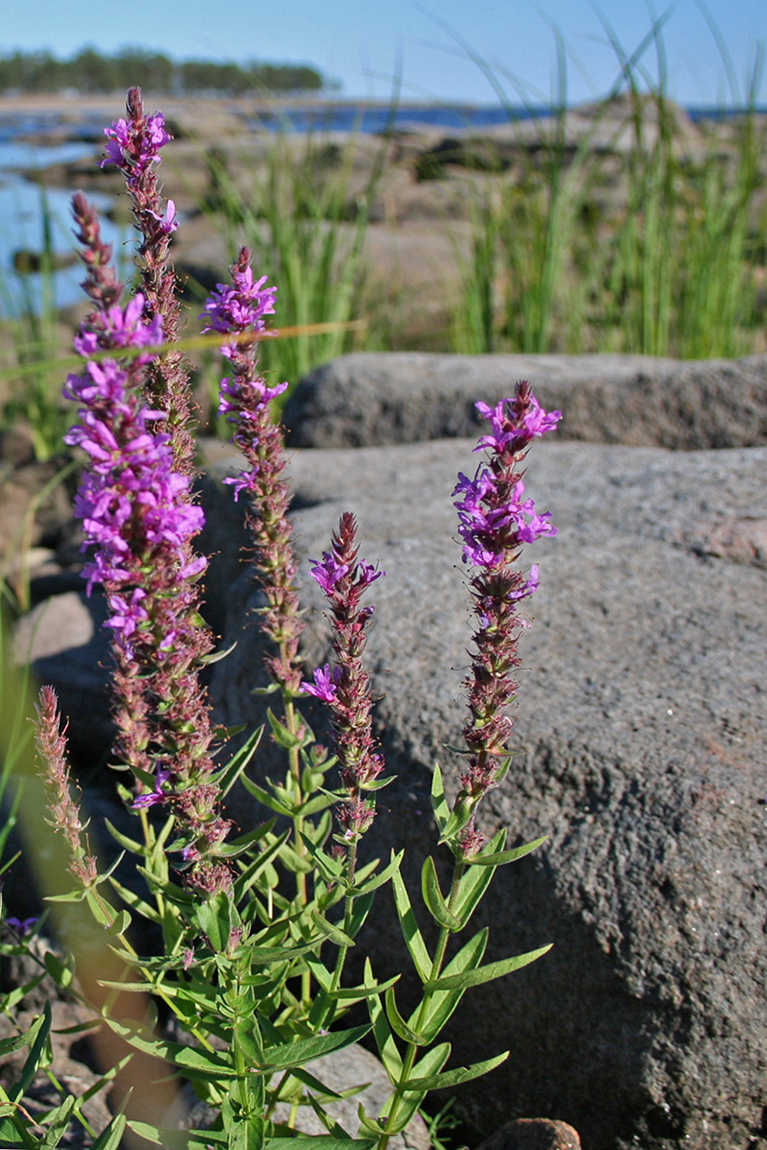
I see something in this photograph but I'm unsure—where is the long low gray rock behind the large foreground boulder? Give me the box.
[285,352,767,451]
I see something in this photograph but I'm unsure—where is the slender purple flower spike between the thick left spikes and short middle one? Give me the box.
[201,247,302,695]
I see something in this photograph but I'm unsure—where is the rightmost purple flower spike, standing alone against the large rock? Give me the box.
[453,382,561,857]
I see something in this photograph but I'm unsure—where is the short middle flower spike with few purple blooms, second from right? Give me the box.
[301,512,384,842]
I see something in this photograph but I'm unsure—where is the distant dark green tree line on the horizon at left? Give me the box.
[0,47,325,95]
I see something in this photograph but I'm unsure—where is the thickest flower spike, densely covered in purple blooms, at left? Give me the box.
[64,198,231,892]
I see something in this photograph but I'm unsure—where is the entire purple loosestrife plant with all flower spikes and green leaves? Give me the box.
[17,90,559,1150]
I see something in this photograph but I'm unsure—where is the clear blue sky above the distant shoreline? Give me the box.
[0,0,767,105]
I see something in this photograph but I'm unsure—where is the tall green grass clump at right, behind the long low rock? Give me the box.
[454,17,767,358]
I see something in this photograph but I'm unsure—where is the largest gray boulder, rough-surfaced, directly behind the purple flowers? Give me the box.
[206,437,767,1150]
